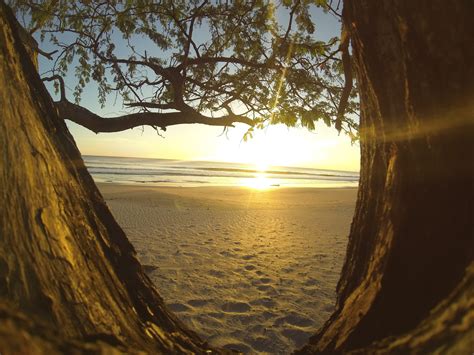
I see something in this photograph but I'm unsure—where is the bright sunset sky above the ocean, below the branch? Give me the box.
[40,2,360,171]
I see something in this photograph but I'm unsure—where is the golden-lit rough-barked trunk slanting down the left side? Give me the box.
[0,2,211,354]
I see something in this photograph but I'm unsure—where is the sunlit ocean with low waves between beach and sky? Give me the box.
[83,155,359,189]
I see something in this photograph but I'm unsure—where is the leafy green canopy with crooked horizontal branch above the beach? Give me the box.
[10,0,357,139]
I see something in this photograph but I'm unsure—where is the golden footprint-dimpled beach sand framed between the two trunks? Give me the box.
[99,184,357,354]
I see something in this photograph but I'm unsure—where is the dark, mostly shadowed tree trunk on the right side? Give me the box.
[302,0,474,353]
